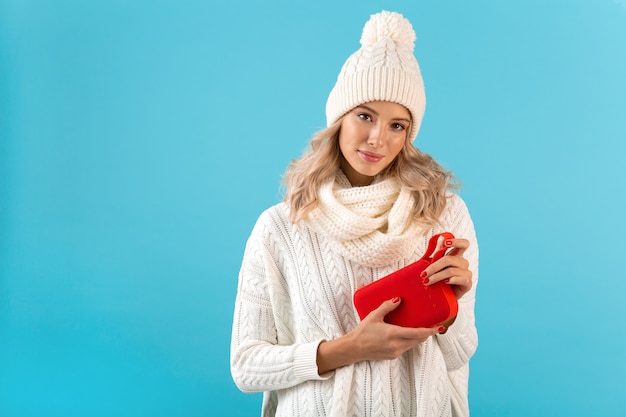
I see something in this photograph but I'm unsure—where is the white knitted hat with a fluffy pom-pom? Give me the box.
[326,11,426,141]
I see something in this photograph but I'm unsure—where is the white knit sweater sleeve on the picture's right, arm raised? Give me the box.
[436,195,478,371]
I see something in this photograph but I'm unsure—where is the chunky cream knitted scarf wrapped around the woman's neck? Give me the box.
[307,171,423,267]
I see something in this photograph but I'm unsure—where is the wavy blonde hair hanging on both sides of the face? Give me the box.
[283,118,459,226]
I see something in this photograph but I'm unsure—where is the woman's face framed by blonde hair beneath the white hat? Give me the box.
[339,101,411,186]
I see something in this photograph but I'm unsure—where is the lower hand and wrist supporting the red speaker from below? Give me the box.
[317,298,441,375]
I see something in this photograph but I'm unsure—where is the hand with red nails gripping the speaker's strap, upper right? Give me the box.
[421,239,472,300]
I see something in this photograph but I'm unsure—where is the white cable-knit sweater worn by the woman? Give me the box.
[231,195,478,417]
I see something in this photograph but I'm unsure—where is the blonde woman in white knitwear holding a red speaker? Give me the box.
[231,11,478,417]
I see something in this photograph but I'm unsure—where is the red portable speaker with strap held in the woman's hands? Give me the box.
[354,232,459,327]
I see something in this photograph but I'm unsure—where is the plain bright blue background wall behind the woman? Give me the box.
[0,0,626,417]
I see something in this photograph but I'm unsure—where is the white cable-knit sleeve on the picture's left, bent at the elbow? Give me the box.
[230,213,330,392]
